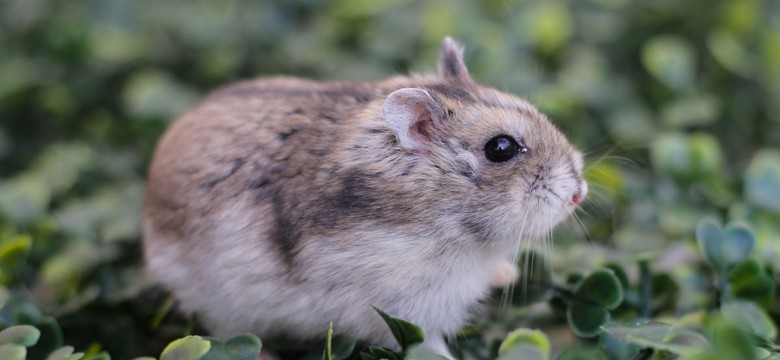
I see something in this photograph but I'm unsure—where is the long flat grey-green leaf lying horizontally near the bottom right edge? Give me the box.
[603,322,710,356]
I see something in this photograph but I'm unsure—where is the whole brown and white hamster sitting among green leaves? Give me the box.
[142,38,587,356]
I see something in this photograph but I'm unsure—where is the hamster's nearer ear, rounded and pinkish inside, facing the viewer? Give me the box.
[383,88,442,150]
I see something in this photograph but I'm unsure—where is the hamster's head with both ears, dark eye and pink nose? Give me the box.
[384,38,588,241]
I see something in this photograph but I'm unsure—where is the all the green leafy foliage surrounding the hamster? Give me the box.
[0,0,780,360]
